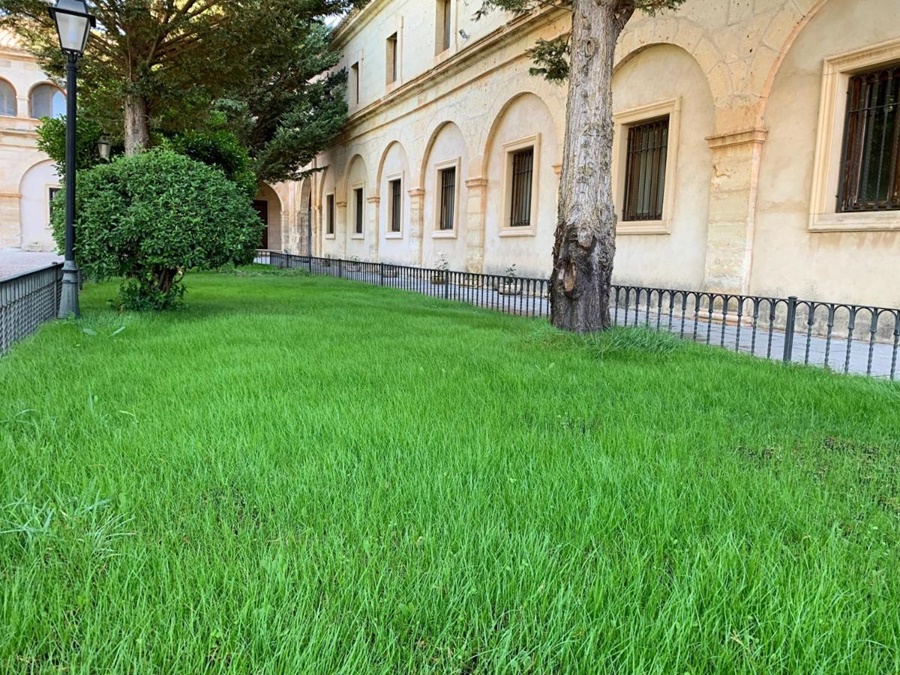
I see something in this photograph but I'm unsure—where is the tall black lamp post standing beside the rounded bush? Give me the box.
[49,0,97,319]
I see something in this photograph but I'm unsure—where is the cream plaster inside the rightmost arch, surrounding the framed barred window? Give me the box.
[751,0,900,307]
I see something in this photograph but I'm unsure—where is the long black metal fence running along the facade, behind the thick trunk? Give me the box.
[257,251,900,380]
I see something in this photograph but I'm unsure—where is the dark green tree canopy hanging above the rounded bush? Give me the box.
[0,0,364,162]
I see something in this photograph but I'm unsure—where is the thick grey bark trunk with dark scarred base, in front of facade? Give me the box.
[550,0,634,333]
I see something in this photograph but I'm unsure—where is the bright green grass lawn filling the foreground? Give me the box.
[0,274,900,674]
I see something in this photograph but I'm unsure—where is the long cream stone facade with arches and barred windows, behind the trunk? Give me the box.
[269,0,900,306]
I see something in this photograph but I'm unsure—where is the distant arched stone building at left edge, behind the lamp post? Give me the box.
[0,31,66,251]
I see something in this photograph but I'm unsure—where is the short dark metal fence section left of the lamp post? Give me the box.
[0,263,62,354]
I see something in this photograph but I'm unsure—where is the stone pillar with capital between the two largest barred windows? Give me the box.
[704,129,766,294]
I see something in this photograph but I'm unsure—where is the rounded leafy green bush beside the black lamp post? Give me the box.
[53,150,263,310]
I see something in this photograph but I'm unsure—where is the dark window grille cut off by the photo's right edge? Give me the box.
[837,64,900,212]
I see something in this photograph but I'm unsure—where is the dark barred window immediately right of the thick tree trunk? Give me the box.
[623,115,669,221]
